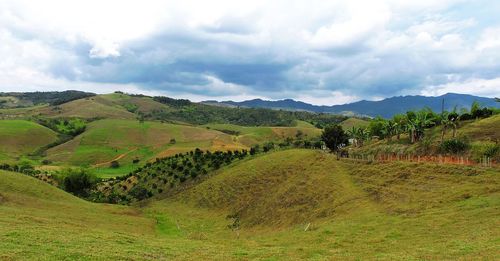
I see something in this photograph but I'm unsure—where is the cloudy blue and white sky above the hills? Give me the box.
[0,0,500,105]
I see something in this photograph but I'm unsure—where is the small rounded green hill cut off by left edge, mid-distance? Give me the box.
[0,120,57,160]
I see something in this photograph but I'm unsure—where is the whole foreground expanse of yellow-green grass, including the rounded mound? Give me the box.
[0,150,500,260]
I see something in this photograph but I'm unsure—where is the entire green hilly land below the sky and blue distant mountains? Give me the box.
[0,92,500,260]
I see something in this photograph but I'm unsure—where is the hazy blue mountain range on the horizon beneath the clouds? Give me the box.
[204,93,499,118]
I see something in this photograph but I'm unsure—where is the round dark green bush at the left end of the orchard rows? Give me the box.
[63,169,97,197]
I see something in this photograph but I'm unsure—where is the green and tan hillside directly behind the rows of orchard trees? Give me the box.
[47,120,245,174]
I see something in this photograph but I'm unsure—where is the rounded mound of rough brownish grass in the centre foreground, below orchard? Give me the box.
[174,150,366,226]
